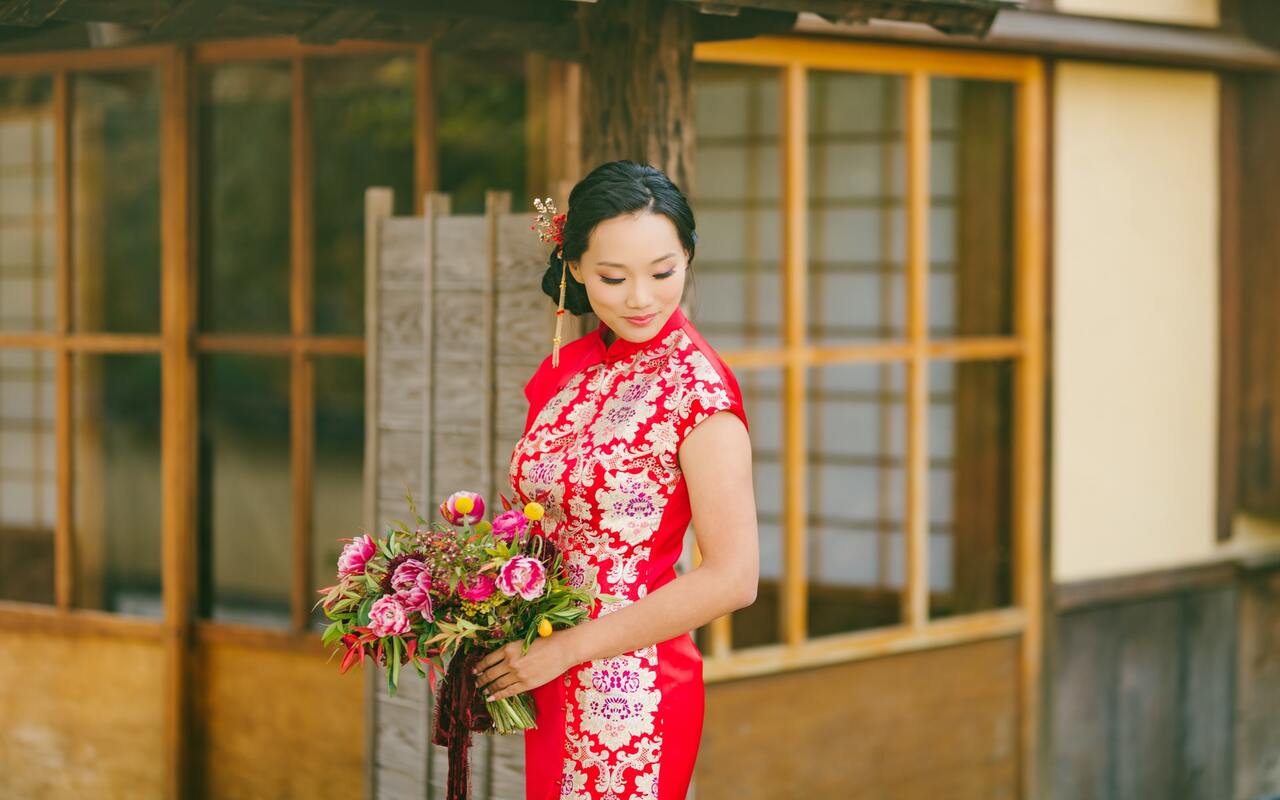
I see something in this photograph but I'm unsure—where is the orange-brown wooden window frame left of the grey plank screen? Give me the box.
[0,38,436,796]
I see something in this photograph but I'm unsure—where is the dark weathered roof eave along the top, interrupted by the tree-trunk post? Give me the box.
[0,0,1018,52]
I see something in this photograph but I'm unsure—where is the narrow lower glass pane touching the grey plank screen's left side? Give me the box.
[311,358,365,623]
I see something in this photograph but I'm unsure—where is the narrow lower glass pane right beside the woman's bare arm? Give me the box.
[732,369,783,648]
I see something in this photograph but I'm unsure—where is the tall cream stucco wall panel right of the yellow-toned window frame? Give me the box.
[1052,63,1221,573]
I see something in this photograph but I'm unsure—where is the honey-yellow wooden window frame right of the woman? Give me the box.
[694,37,1047,788]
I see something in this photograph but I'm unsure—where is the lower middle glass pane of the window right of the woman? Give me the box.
[808,364,906,636]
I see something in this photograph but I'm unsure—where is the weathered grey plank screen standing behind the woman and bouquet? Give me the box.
[366,189,554,800]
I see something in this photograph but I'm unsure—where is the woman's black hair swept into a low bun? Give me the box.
[543,160,698,316]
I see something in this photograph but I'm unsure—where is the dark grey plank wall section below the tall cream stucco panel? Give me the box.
[1050,568,1238,800]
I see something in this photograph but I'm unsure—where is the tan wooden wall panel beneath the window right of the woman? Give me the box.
[696,637,1013,800]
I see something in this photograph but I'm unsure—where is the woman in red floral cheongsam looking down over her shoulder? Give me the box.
[476,161,759,800]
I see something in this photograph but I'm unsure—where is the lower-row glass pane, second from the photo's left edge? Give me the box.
[72,353,164,618]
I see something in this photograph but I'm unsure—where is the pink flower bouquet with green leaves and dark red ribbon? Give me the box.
[316,492,600,799]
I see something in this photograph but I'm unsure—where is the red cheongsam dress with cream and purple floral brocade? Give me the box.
[509,308,746,800]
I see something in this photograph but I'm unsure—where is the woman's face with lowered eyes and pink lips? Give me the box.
[570,211,689,342]
